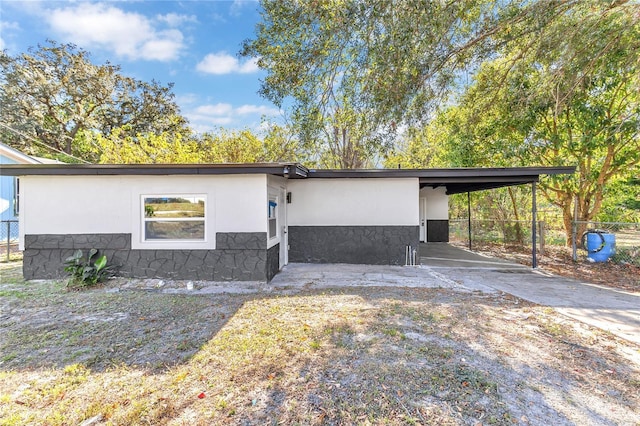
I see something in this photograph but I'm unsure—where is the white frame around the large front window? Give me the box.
[136,192,210,250]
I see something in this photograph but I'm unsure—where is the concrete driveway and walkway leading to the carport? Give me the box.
[269,244,640,345]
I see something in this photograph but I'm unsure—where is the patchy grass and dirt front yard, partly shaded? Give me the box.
[0,267,640,425]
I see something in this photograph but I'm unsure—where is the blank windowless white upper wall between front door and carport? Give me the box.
[287,178,419,226]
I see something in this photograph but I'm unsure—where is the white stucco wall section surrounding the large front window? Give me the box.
[20,175,267,248]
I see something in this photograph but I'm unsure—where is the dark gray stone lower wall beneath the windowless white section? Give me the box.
[289,226,420,265]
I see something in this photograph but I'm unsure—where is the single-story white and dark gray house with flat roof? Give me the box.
[0,163,574,281]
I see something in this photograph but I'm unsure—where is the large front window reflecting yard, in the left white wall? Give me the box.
[142,195,206,241]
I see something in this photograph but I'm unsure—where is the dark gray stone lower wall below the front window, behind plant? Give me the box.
[23,232,270,281]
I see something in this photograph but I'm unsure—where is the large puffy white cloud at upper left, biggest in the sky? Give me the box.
[45,3,184,61]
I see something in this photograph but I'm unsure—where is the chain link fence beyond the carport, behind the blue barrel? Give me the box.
[449,218,640,266]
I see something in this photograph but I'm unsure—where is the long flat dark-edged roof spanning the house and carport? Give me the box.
[0,163,575,194]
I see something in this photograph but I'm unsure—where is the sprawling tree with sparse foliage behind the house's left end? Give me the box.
[0,41,186,160]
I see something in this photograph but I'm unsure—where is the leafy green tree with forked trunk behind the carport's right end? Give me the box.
[412,10,640,243]
